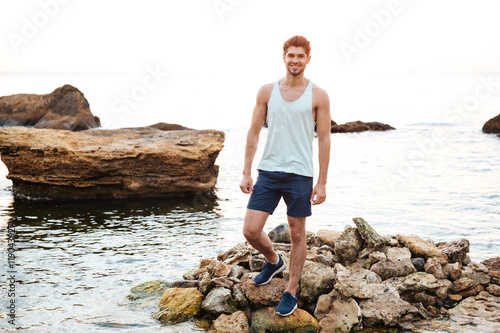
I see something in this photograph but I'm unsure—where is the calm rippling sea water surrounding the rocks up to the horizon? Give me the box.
[0,74,500,332]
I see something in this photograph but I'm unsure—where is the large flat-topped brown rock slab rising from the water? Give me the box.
[0,127,224,200]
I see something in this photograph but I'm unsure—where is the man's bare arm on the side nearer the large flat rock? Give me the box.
[240,84,273,193]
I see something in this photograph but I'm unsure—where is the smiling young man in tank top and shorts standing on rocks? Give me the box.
[240,36,331,316]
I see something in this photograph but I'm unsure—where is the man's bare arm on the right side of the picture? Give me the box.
[311,88,332,205]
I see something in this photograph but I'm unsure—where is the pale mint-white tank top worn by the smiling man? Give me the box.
[257,80,314,177]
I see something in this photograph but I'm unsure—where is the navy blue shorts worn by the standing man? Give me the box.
[247,170,313,217]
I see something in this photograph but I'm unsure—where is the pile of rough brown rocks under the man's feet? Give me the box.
[141,218,500,332]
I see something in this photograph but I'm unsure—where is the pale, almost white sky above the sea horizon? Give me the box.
[0,0,500,75]
